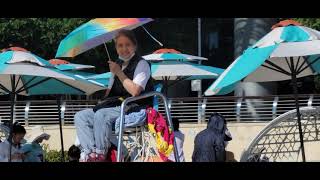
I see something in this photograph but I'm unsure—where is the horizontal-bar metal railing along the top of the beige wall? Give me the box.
[0,94,320,126]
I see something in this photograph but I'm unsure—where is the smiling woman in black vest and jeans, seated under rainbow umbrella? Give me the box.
[74,30,153,162]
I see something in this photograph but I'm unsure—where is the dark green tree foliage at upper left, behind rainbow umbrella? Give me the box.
[0,18,88,58]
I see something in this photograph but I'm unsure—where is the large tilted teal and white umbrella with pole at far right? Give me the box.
[205,21,320,161]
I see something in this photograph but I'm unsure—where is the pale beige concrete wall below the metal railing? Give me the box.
[27,123,266,161]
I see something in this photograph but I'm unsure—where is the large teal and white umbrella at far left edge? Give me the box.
[0,51,105,161]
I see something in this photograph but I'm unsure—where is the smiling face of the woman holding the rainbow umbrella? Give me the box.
[116,36,136,59]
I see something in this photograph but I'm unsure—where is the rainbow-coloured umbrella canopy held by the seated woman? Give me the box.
[56,18,153,57]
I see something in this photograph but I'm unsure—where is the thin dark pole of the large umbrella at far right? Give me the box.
[291,72,306,162]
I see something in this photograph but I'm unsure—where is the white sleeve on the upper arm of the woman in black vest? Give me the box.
[133,60,151,90]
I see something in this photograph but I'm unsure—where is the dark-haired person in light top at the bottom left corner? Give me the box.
[0,123,26,162]
